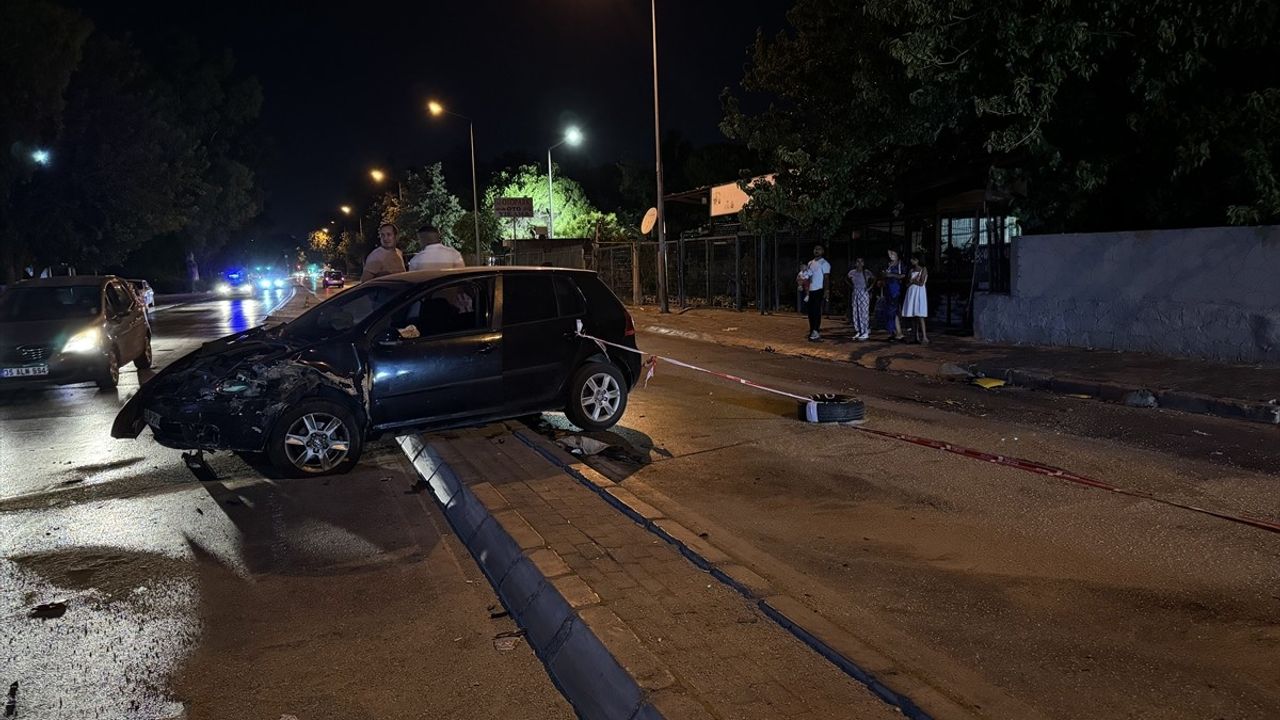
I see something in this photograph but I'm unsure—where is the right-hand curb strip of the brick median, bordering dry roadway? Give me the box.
[512,428,932,720]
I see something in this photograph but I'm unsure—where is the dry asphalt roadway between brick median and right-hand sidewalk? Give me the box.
[544,333,1280,719]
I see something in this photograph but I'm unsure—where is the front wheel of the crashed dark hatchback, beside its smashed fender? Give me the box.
[266,398,365,477]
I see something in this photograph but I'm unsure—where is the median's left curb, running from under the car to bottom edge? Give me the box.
[397,434,663,720]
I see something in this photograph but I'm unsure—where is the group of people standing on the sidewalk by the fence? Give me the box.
[796,245,929,345]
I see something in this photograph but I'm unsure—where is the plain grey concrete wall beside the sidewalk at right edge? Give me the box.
[974,225,1280,364]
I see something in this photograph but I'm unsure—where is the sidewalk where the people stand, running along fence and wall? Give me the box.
[631,307,1280,424]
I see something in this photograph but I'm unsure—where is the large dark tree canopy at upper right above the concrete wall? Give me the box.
[723,0,1280,229]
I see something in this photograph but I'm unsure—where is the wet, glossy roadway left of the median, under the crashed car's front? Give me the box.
[0,288,572,720]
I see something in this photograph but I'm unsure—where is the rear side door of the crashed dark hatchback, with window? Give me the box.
[502,272,580,409]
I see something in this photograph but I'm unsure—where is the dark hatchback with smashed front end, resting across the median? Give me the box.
[111,268,640,475]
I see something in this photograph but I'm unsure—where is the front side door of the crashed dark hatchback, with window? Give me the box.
[369,277,503,429]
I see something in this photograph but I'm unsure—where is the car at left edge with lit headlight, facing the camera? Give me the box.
[0,275,151,389]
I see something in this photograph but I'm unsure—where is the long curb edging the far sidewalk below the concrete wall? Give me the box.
[645,325,1280,425]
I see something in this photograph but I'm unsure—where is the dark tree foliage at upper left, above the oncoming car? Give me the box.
[0,0,261,279]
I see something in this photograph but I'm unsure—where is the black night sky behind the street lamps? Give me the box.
[72,0,790,236]
